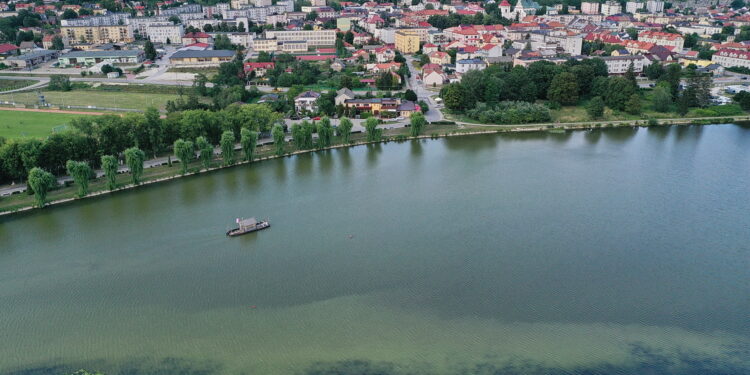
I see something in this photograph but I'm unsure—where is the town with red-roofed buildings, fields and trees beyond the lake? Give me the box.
[0,0,750,209]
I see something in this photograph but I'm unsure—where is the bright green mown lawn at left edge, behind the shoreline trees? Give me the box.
[0,111,92,139]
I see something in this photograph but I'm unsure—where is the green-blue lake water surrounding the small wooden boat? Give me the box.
[0,125,750,375]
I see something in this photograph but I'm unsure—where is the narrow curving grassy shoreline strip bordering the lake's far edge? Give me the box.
[0,116,750,217]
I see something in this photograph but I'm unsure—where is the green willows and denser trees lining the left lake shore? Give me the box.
[0,104,427,207]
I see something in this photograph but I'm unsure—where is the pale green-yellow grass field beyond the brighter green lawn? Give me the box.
[0,89,184,110]
